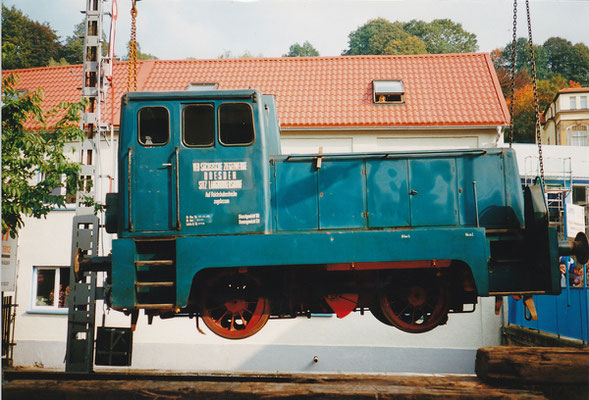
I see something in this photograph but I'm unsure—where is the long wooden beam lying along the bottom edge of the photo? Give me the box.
[2,375,546,400]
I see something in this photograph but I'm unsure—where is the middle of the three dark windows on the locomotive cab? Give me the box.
[182,104,215,147]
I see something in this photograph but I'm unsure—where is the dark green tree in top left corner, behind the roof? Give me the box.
[2,5,61,70]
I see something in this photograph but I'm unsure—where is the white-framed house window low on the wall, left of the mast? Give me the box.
[32,267,70,311]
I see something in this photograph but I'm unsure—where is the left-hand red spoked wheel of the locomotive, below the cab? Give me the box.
[201,274,270,339]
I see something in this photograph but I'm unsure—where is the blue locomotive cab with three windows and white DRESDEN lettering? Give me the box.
[107,90,280,237]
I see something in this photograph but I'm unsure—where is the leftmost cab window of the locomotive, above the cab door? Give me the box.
[137,106,170,146]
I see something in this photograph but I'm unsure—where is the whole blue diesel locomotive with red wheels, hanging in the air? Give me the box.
[94,90,587,339]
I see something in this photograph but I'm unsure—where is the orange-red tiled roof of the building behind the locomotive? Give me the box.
[4,53,509,128]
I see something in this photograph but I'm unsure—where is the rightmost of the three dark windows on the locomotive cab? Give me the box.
[219,103,254,146]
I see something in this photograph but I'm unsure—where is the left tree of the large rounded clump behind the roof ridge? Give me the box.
[342,18,427,55]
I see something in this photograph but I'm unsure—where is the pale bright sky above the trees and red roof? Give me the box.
[3,0,589,59]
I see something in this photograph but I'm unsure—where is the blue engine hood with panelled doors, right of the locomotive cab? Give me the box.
[273,149,523,231]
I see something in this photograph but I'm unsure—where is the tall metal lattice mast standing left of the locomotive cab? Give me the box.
[65,0,113,373]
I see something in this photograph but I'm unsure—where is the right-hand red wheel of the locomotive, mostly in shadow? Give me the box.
[377,279,449,333]
